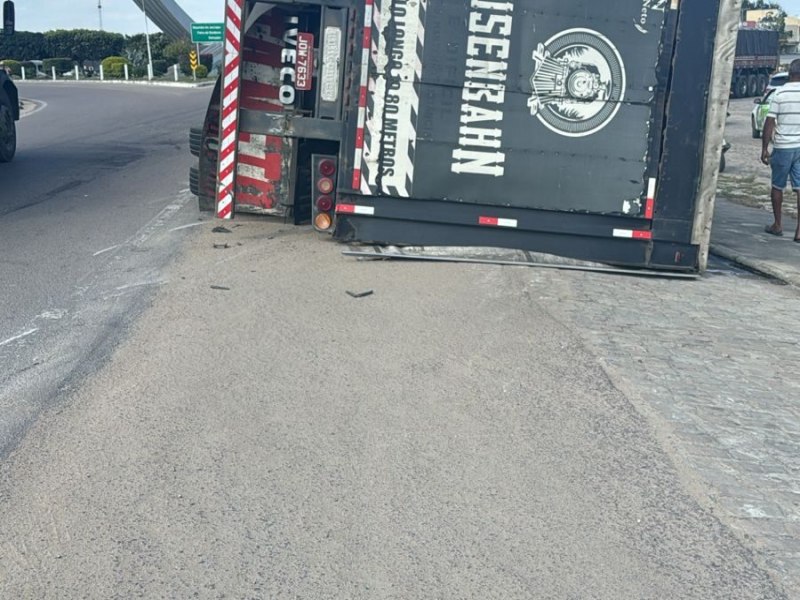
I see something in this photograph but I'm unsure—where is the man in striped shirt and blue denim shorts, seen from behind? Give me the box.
[761,59,800,242]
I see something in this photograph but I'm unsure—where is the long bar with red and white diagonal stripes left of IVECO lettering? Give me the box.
[217,0,244,219]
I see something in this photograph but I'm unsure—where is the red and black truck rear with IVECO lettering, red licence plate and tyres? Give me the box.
[191,2,346,223]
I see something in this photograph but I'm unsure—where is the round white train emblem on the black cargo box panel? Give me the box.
[528,29,626,137]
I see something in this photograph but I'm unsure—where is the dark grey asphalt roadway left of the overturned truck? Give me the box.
[0,82,210,457]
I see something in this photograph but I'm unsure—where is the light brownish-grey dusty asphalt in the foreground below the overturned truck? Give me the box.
[0,218,785,600]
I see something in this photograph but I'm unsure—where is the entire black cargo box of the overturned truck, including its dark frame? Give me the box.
[335,0,735,271]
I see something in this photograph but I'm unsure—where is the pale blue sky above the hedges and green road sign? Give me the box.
[14,0,225,35]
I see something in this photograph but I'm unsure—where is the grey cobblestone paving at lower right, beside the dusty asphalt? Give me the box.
[530,265,800,598]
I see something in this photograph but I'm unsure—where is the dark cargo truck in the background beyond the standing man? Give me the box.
[731,28,780,98]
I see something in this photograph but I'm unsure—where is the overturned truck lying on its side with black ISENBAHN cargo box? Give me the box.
[191,0,740,272]
